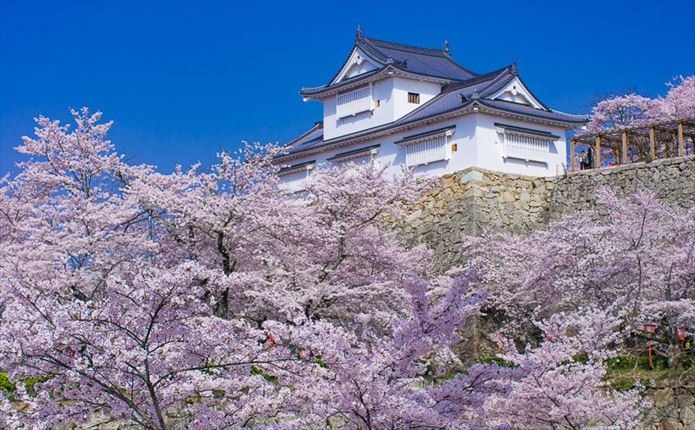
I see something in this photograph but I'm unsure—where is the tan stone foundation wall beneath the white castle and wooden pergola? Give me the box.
[399,156,695,270]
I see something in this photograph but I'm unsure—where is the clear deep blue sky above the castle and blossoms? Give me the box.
[0,0,695,173]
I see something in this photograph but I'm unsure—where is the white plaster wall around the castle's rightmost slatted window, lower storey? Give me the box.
[475,114,567,176]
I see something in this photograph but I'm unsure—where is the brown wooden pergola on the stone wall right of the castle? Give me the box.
[570,118,695,171]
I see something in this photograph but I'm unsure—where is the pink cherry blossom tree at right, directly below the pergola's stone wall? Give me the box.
[470,189,695,362]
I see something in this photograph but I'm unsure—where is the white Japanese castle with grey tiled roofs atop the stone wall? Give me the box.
[276,28,587,189]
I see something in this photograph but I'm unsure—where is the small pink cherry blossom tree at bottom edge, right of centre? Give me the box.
[484,308,647,429]
